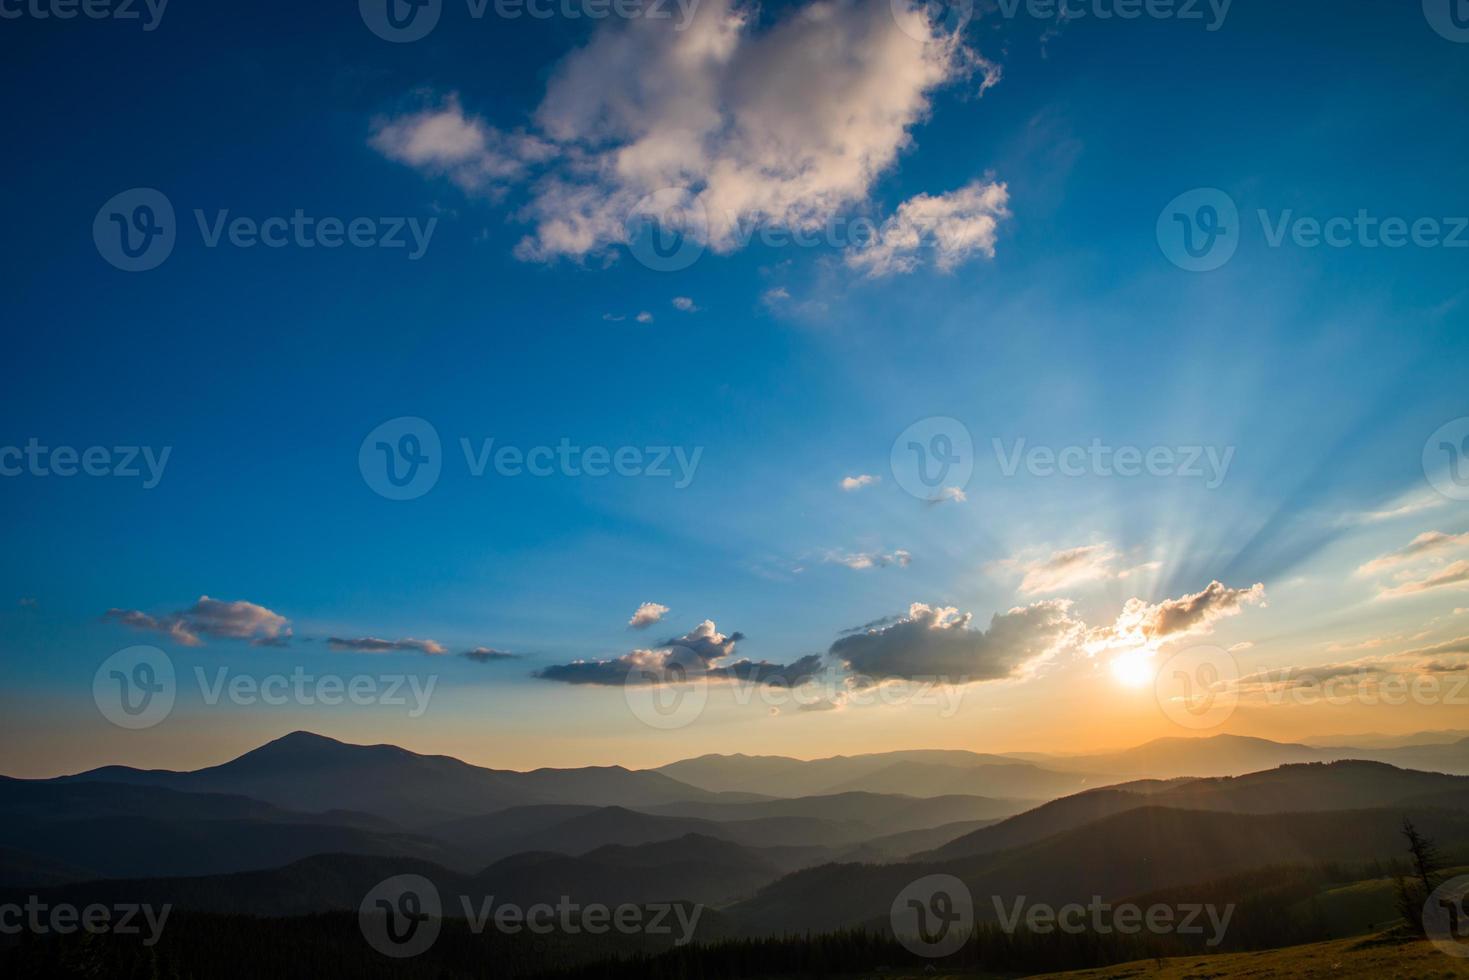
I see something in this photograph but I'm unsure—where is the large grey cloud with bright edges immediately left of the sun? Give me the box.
[830,599,1083,683]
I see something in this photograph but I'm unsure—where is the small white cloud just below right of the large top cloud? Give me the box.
[846,181,1009,279]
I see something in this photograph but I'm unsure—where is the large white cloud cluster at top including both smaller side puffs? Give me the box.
[372,0,1005,275]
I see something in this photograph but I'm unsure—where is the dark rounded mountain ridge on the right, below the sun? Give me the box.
[914,761,1469,861]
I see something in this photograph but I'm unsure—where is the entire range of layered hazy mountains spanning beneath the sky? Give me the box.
[0,732,1469,933]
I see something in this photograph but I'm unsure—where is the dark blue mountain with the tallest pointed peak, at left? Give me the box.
[60,732,734,827]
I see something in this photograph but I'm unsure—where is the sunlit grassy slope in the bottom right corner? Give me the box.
[1047,936,1469,980]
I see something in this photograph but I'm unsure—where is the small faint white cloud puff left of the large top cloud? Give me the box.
[369,93,555,192]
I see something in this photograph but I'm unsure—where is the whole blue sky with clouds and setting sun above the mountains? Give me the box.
[0,0,1469,776]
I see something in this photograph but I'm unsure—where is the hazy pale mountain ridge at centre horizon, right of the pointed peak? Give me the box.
[655,749,1096,799]
